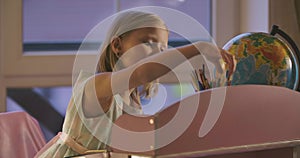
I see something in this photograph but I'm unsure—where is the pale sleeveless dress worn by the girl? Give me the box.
[38,72,140,158]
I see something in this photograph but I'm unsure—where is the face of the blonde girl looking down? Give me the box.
[117,27,168,67]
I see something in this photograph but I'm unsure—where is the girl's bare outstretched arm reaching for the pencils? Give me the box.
[84,42,233,116]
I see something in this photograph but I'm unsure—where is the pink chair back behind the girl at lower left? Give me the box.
[0,112,46,158]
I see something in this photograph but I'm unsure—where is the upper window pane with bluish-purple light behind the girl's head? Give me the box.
[23,0,211,54]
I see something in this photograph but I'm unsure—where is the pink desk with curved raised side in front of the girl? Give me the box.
[111,85,300,158]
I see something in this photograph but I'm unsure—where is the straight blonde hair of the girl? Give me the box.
[98,10,167,104]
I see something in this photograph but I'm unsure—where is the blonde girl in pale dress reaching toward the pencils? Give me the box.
[36,11,235,157]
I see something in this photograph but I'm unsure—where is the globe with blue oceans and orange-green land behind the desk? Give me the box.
[223,32,299,89]
